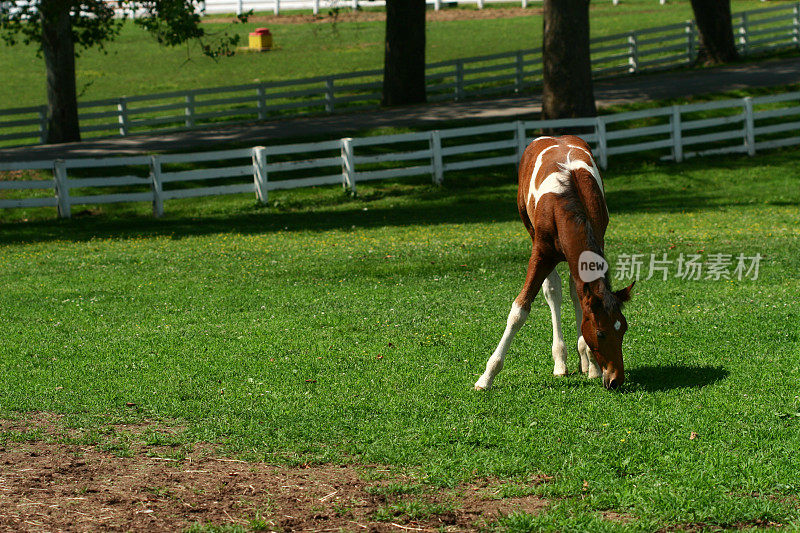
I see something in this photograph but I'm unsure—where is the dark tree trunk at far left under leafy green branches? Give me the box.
[40,0,81,144]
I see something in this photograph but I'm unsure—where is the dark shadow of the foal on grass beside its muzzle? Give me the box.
[626,365,730,392]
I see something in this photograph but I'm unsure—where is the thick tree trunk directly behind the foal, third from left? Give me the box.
[542,0,597,124]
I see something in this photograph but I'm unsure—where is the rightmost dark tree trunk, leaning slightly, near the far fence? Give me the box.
[692,0,739,64]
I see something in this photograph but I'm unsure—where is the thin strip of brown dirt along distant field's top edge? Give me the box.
[203,7,542,24]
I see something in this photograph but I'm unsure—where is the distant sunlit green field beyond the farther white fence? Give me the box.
[0,0,763,109]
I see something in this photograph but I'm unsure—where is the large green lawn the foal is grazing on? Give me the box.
[0,150,800,530]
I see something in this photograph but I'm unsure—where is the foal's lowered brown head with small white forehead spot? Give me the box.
[581,278,635,390]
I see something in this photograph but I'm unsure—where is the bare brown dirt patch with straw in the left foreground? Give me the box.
[0,415,548,532]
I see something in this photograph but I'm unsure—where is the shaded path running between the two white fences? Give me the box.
[0,57,800,161]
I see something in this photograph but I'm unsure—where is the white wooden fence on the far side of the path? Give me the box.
[0,2,800,145]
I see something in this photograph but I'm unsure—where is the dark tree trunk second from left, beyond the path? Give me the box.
[381,0,425,106]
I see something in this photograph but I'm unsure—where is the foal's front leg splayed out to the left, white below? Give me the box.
[475,245,555,390]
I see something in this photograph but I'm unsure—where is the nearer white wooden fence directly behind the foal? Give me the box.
[0,92,800,217]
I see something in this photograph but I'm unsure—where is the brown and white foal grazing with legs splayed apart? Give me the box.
[475,135,633,390]
